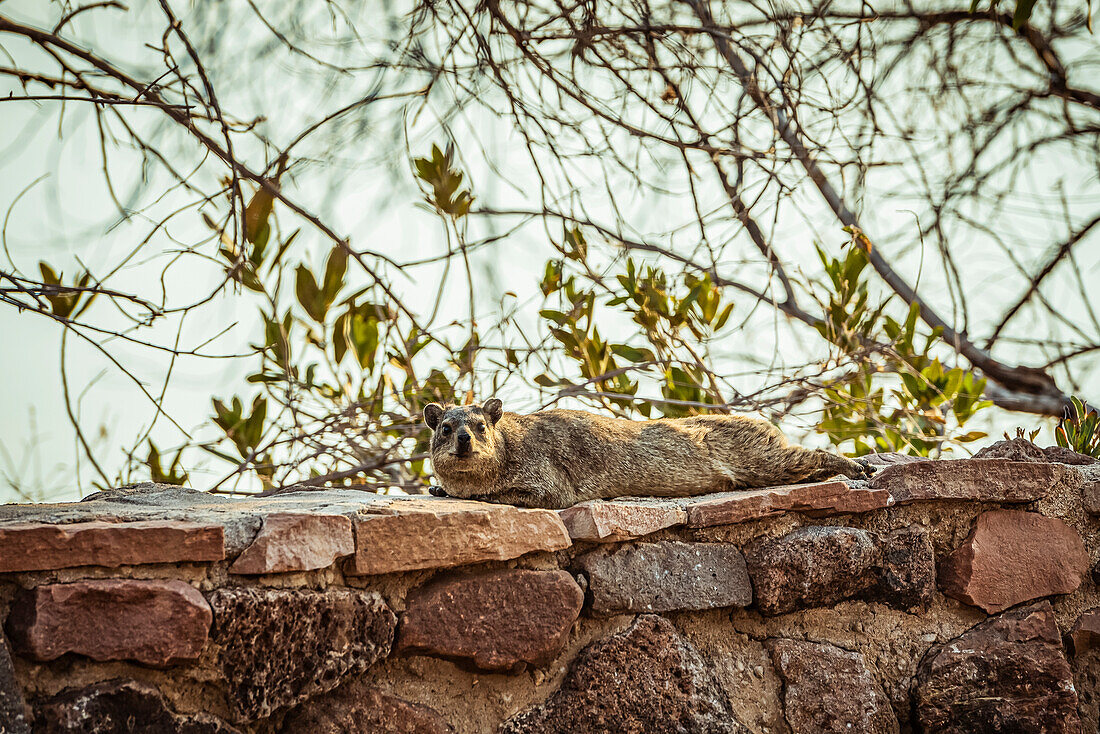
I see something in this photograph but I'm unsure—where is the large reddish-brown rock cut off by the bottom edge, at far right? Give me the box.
[915,601,1080,734]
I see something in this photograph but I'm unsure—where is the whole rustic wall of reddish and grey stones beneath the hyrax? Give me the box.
[0,446,1100,734]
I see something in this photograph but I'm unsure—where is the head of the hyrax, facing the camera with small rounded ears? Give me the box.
[424,397,504,481]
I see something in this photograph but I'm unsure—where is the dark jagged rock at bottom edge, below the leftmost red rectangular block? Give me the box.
[34,680,237,734]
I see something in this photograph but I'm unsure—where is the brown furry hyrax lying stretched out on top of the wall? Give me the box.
[424,398,867,508]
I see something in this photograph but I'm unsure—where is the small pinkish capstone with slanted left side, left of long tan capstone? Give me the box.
[229,513,355,574]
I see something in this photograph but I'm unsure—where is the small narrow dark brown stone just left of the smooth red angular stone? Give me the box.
[867,525,936,612]
